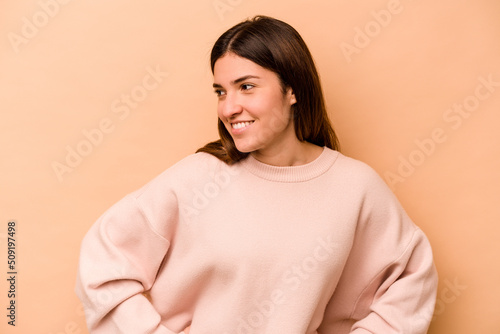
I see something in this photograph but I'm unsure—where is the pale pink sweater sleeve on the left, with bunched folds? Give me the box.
[76,195,175,334]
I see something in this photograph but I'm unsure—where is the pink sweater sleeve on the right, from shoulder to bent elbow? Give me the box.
[319,167,437,334]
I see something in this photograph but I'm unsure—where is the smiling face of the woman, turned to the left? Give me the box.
[214,53,298,153]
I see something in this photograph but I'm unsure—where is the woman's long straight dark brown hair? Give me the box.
[196,16,339,164]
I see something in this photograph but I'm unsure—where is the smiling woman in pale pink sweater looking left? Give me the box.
[76,16,437,334]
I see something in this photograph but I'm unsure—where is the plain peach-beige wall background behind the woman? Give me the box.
[0,0,500,334]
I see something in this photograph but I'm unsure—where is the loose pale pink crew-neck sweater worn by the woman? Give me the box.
[76,148,437,334]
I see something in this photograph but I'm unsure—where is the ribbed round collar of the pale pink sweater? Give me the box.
[240,147,339,183]
